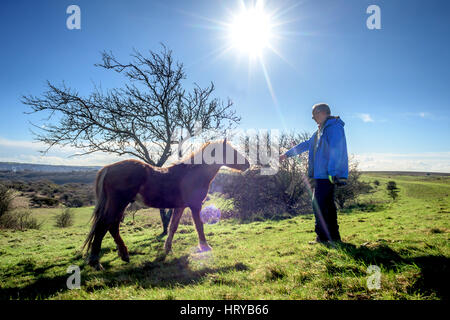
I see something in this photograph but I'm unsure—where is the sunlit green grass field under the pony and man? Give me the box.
[0,173,450,299]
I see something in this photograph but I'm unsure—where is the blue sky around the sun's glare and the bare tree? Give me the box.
[0,0,450,172]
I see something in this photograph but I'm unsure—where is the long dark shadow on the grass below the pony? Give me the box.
[0,253,248,300]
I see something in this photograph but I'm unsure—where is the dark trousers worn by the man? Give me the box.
[312,179,341,241]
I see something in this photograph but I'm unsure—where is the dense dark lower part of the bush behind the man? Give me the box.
[222,159,372,221]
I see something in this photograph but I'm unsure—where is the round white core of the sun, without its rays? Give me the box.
[228,2,273,57]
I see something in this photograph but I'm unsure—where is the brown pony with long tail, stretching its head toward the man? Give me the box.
[83,139,250,269]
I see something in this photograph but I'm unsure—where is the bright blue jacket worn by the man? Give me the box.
[285,116,348,179]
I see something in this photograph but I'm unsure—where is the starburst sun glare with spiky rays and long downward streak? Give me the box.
[181,0,294,127]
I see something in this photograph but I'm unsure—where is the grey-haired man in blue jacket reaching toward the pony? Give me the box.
[280,103,348,243]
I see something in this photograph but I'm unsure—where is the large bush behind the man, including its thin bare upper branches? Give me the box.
[209,133,372,221]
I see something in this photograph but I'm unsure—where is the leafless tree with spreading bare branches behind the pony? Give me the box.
[22,44,240,234]
